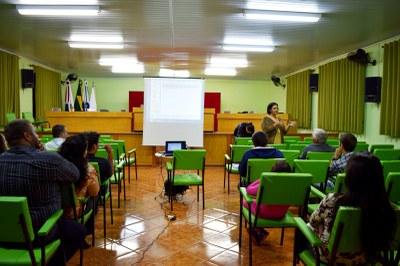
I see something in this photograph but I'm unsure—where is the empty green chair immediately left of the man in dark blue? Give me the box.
[224,144,252,193]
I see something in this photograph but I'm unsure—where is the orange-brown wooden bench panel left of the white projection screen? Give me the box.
[46,112,132,133]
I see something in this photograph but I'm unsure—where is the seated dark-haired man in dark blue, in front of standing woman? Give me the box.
[239,131,283,183]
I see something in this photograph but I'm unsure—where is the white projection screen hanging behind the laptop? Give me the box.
[142,78,204,147]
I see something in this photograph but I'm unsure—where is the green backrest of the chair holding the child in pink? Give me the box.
[257,172,312,206]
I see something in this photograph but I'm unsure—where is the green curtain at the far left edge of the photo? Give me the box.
[0,51,20,125]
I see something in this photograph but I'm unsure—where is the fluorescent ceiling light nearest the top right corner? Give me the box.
[244,10,321,22]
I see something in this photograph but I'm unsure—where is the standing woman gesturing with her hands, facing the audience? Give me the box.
[261,102,296,144]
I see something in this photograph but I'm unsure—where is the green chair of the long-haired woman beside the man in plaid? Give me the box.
[60,184,95,266]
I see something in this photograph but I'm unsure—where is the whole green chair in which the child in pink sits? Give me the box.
[239,173,312,265]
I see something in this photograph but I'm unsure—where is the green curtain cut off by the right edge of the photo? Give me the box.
[380,40,400,138]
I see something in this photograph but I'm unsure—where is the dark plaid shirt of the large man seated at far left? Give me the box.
[0,146,79,240]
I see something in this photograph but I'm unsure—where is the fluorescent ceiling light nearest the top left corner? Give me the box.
[17,5,100,16]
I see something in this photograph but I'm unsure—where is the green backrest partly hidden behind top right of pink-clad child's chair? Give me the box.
[293,159,330,183]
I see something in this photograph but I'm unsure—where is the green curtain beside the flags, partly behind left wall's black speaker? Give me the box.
[34,66,62,120]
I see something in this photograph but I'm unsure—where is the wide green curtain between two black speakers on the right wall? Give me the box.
[318,58,366,134]
